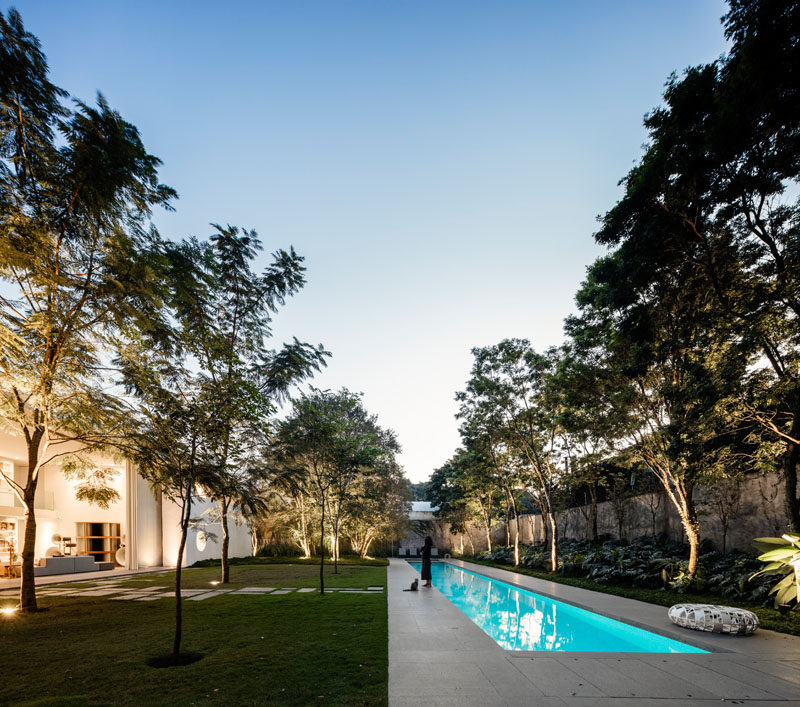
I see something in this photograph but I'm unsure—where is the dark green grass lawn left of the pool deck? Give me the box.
[0,563,388,705]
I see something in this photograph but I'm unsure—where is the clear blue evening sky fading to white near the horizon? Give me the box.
[9,0,726,482]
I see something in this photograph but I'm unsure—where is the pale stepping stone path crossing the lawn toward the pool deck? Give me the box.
[0,578,384,601]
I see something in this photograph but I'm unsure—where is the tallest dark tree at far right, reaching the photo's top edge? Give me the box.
[596,0,800,530]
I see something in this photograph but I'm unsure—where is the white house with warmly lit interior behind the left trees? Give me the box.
[0,431,250,574]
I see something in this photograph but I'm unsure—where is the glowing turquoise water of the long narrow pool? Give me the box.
[409,562,707,653]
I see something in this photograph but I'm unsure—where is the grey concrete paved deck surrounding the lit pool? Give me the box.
[388,559,800,707]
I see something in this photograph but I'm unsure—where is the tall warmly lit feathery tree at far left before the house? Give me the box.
[0,10,175,611]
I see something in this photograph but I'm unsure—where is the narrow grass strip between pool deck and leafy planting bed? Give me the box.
[463,557,800,636]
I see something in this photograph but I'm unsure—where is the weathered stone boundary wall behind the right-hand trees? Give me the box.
[424,473,787,554]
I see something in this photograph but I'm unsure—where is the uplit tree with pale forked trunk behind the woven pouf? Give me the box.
[570,250,749,576]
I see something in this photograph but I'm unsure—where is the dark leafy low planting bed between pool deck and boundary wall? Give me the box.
[463,538,800,636]
